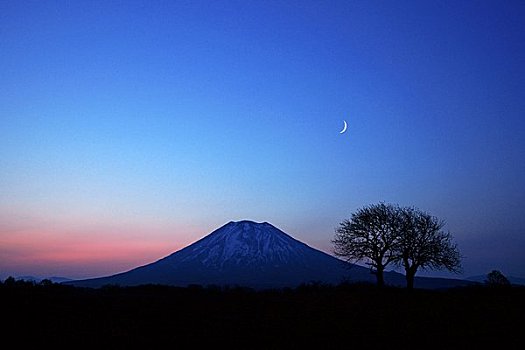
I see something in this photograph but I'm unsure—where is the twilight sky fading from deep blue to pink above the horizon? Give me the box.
[0,0,525,278]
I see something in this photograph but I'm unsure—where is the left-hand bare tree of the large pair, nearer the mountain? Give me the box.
[332,203,400,287]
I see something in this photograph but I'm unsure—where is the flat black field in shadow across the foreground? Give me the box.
[0,282,525,349]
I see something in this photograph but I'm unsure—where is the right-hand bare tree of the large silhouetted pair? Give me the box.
[392,208,461,289]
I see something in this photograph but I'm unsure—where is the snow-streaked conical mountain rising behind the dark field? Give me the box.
[69,220,468,289]
